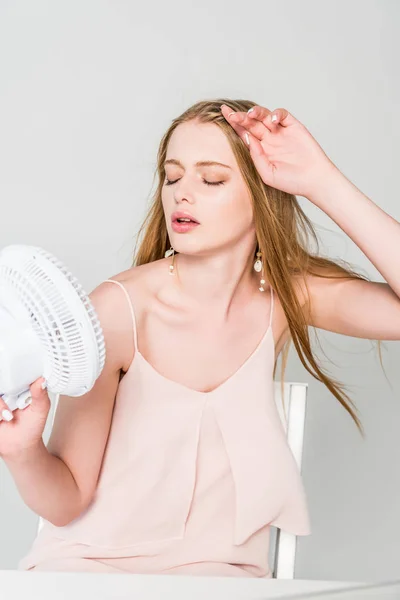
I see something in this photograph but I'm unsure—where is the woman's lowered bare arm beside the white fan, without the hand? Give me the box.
[4,283,129,526]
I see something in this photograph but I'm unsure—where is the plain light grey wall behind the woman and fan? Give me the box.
[0,0,400,581]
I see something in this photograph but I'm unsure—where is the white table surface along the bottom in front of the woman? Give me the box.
[0,570,394,600]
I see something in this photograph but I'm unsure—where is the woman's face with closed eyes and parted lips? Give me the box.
[161,121,254,255]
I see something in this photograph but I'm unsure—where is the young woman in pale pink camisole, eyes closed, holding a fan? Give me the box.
[0,99,400,577]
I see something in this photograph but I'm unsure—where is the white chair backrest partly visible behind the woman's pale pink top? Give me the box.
[269,381,308,579]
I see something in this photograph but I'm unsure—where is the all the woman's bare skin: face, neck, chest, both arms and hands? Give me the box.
[0,106,400,524]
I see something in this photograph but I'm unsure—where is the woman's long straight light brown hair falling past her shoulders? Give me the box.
[133,98,383,437]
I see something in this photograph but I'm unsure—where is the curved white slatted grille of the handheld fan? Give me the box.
[0,245,105,395]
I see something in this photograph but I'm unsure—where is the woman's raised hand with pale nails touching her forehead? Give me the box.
[221,104,339,198]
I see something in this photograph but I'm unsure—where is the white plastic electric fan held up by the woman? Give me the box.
[0,245,106,411]
